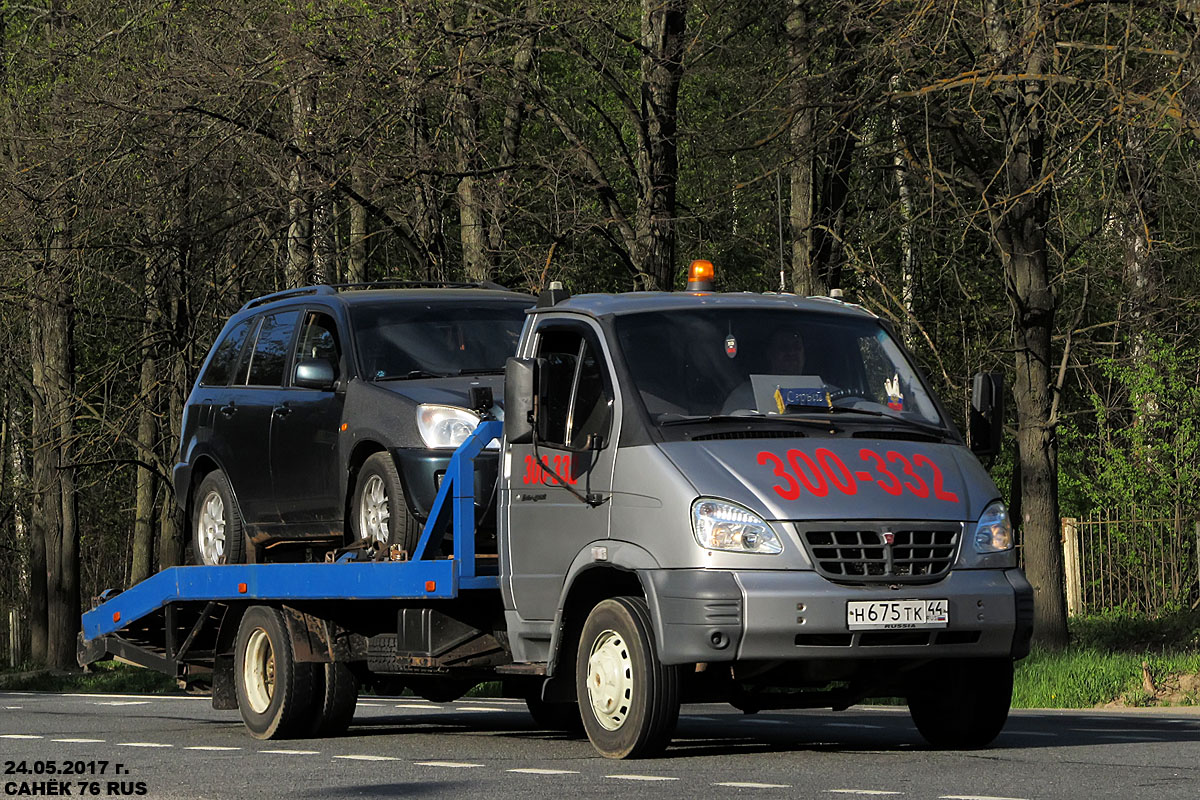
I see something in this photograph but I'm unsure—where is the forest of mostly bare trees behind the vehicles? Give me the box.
[0,0,1200,667]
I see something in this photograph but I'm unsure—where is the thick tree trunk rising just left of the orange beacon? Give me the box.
[632,0,688,290]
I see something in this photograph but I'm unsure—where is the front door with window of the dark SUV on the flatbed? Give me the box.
[271,309,346,527]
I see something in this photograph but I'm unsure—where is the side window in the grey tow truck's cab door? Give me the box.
[538,330,612,447]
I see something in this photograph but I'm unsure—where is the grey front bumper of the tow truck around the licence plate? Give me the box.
[644,570,1033,663]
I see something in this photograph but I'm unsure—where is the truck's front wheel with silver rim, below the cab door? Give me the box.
[575,597,679,758]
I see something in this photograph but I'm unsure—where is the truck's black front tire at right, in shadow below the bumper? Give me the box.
[908,658,1013,750]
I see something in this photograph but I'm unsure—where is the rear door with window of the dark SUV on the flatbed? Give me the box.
[212,311,300,525]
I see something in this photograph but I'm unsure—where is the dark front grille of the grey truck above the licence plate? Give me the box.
[800,523,962,583]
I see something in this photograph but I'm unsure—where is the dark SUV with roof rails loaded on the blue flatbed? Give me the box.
[173,282,534,564]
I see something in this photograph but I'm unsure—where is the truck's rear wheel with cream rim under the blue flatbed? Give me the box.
[233,606,314,739]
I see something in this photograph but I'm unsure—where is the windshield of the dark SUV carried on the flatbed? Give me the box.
[350,300,526,380]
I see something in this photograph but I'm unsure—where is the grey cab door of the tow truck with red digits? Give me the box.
[505,320,617,620]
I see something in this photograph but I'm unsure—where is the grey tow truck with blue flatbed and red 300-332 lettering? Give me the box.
[79,273,1032,758]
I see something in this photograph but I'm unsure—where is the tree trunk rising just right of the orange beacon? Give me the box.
[785,0,828,296]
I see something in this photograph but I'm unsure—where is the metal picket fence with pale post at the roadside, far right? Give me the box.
[1062,510,1200,615]
